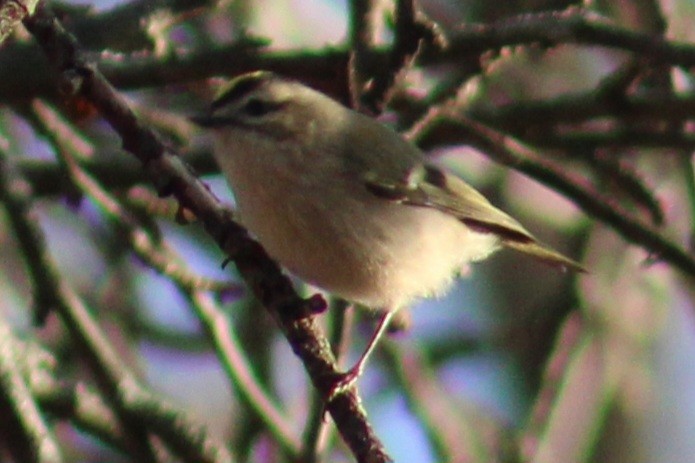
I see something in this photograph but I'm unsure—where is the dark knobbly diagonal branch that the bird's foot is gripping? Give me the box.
[25,4,389,462]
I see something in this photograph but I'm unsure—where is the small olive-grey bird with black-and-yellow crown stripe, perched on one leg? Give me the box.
[193,71,582,392]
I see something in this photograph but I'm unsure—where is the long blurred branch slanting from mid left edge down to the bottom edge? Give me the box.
[0,151,230,463]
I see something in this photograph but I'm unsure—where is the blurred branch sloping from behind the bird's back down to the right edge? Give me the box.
[409,110,695,275]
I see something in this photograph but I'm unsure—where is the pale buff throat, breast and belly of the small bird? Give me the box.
[215,136,499,309]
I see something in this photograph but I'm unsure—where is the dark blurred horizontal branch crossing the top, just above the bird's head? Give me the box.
[0,9,695,103]
